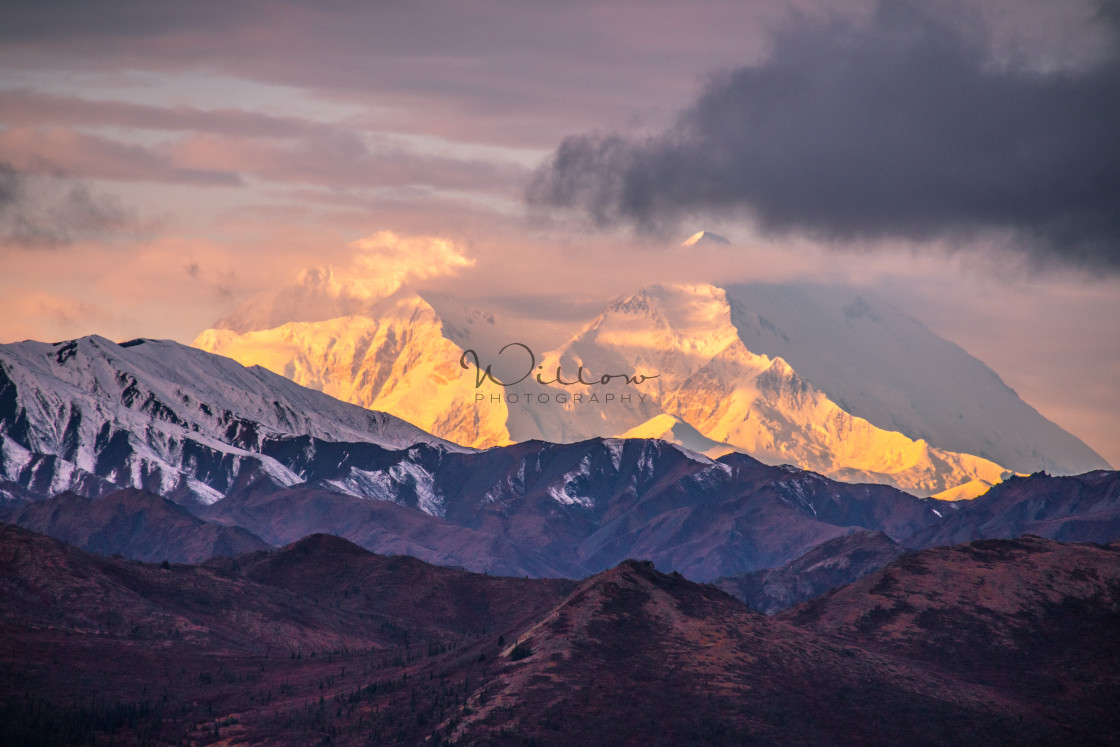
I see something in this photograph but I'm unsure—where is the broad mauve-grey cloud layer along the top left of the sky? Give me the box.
[0,0,797,148]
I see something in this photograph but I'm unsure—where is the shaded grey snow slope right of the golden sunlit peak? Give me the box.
[727,284,1109,474]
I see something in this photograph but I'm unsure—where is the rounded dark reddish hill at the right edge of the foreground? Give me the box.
[780,535,1120,734]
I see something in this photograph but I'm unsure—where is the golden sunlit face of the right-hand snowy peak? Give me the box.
[528,286,1005,495]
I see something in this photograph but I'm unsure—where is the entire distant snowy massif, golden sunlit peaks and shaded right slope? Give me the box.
[188,276,1107,498]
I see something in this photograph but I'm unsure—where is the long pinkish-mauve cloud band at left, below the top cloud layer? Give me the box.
[0,90,529,199]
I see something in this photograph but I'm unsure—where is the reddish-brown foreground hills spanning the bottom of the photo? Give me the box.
[0,524,1120,745]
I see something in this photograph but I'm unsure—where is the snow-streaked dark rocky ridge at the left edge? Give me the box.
[0,336,460,503]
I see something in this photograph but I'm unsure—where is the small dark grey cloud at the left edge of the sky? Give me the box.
[0,161,132,251]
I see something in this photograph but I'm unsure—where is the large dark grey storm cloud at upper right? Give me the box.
[529,2,1120,269]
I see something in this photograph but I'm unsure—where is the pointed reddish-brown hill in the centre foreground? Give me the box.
[448,561,1084,745]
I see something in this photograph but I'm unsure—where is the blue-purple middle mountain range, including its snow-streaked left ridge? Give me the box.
[0,337,1120,586]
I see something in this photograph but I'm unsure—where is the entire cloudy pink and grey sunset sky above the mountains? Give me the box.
[0,0,1120,466]
